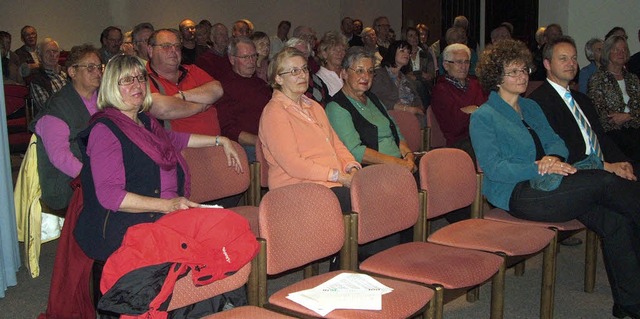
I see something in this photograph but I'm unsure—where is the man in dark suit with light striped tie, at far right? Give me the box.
[529,37,640,318]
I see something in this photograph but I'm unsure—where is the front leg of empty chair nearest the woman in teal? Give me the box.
[540,233,558,319]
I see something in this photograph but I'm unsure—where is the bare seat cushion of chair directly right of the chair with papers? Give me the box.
[360,242,504,289]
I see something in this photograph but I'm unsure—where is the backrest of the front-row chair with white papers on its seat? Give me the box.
[259,183,344,275]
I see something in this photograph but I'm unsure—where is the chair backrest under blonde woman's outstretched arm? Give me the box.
[182,142,250,203]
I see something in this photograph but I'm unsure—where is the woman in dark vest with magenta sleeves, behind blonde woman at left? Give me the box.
[30,45,102,210]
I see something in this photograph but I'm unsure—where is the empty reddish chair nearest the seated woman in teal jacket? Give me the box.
[419,148,557,318]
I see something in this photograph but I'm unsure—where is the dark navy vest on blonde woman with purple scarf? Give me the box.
[73,113,185,260]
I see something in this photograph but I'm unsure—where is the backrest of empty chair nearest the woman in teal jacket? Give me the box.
[419,148,477,219]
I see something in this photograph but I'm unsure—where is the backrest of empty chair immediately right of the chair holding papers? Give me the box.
[351,164,419,244]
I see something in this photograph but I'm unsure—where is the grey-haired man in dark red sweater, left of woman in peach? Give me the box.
[216,37,271,162]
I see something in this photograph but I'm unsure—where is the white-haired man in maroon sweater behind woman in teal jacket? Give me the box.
[431,43,487,159]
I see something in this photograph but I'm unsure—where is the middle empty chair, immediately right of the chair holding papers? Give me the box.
[349,164,504,318]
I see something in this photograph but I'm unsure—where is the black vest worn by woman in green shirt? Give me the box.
[331,90,400,151]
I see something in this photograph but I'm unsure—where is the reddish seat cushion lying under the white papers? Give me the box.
[269,271,434,319]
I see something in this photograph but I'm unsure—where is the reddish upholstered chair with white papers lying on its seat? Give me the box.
[250,183,433,318]
